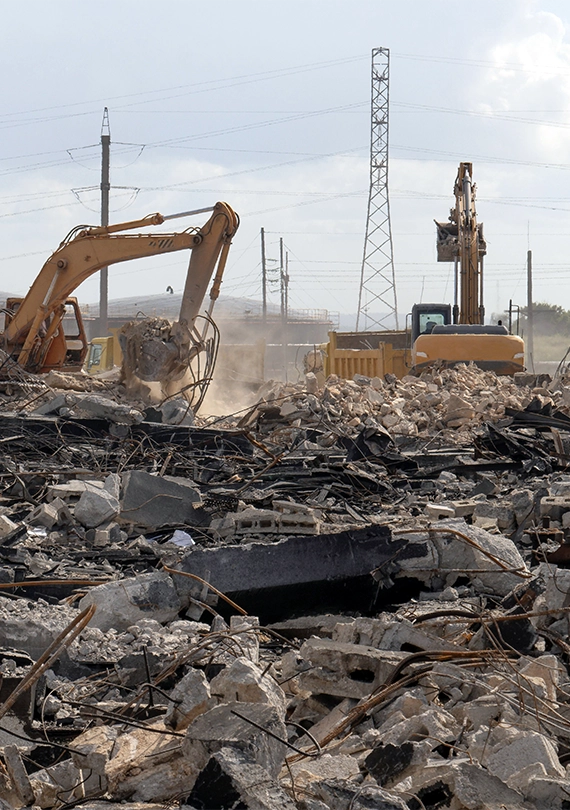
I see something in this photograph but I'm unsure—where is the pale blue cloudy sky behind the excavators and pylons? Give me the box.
[0,0,570,326]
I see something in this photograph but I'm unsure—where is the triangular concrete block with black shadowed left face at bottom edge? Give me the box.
[183,748,297,810]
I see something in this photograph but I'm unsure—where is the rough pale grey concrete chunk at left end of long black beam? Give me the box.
[79,571,184,631]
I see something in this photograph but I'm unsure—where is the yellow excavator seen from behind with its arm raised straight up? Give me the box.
[412,163,524,375]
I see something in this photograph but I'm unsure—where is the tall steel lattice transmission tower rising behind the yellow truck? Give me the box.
[356,48,398,331]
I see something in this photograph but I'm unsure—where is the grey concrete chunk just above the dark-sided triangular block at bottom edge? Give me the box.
[183,702,288,778]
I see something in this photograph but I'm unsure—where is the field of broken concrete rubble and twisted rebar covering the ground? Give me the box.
[4,366,570,810]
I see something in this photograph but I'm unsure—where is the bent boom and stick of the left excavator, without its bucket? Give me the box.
[3,202,238,372]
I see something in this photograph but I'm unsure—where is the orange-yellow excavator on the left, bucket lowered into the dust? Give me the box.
[0,202,239,405]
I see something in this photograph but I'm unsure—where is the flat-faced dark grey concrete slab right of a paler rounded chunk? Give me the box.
[119,470,203,529]
